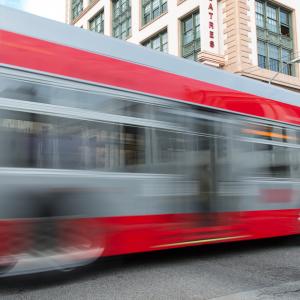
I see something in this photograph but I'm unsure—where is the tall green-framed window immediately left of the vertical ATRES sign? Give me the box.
[181,11,200,61]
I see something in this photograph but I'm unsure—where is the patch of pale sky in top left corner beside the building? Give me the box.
[0,0,65,22]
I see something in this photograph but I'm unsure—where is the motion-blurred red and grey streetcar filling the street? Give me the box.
[0,6,300,275]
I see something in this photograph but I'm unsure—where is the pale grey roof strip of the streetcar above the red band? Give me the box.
[0,5,300,106]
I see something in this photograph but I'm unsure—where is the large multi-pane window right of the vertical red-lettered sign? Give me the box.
[255,0,293,75]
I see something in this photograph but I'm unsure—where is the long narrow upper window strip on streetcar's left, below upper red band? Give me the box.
[0,78,176,122]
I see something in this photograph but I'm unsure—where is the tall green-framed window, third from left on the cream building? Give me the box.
[113,0,131,40]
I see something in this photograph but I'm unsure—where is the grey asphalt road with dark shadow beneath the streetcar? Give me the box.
[0,236,300,300]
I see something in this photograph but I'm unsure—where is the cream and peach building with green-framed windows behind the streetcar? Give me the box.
[66,0,300,92]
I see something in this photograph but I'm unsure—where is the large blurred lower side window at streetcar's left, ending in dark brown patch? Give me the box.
[0,111,145,172]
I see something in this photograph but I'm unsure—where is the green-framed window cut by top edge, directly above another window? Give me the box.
[142,0,168,25]
